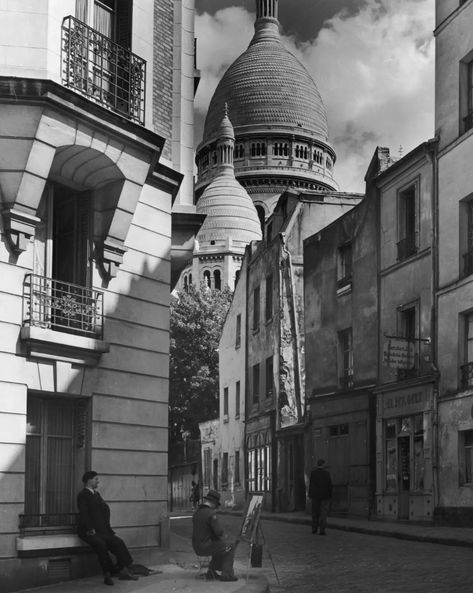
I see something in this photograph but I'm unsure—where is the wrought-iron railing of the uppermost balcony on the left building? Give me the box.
[61,16,146,124]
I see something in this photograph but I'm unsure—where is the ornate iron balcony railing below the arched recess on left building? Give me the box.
[23,274,103,340]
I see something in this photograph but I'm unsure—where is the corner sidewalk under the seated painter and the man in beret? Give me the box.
[20,533,269,593]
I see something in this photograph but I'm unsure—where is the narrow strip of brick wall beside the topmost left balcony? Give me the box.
[153,0,174,159]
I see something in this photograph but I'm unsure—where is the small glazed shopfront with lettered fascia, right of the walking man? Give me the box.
[376,383,434,521]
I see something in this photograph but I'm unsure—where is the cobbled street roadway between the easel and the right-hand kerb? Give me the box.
[171,515,473,593]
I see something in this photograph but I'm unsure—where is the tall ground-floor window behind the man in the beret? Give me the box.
[25,395,87,527]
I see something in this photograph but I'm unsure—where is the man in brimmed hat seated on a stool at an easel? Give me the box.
[192,490,238,581]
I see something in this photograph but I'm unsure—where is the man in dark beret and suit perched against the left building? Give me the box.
[77,471,138,585]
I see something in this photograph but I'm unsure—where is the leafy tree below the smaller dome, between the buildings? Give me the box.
[169,285,232,443]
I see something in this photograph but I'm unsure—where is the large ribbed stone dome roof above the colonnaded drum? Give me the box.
[203,19,328,142]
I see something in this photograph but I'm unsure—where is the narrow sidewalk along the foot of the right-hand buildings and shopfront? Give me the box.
[230,511,473,547]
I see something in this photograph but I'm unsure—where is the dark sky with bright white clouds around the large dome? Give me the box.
[195,0,435,192]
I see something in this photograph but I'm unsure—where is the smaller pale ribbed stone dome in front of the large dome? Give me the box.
[197,169,262,247]
